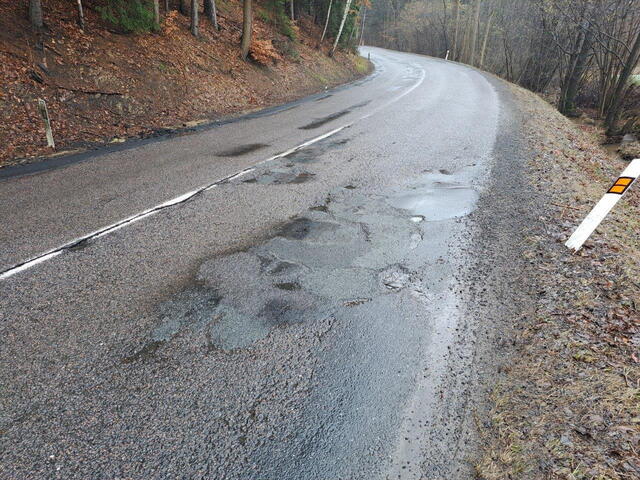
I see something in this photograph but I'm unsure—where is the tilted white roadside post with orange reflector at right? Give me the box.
[565,159,640,252]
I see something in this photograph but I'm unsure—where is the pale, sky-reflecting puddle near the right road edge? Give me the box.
[389,181,478,223]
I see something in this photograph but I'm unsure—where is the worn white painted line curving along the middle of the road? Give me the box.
[0,62,426,280]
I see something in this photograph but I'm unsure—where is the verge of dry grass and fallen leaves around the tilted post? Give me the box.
[476,87,640,480]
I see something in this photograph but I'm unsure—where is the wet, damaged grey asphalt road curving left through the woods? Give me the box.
[0,48,517,480]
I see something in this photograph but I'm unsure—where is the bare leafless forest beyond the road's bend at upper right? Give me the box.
[364,0,640,137]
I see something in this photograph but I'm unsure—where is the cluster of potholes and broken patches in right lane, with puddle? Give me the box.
[122,144,478,363]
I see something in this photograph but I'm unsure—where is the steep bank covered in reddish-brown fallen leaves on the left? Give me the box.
[0,0,369,167]
